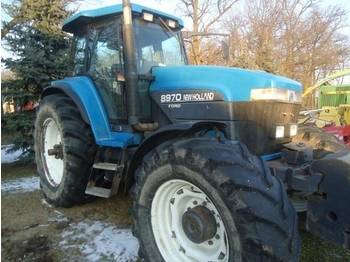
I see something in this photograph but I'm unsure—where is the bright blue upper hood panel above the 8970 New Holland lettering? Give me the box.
[150,66,302,102]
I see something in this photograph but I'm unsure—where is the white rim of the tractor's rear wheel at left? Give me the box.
[42,118,63,187]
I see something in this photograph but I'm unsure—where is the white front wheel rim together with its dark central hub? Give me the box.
[151,179,230,261]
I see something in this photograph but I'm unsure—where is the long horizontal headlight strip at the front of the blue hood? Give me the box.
[250,87,302,103]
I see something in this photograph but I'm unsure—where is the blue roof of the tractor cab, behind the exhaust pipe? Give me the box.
[62,4,184,33]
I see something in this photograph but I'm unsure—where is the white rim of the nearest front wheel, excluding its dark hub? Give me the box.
[151,179,229,261]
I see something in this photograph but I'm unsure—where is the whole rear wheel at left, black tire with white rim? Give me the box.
[35,94,97,207]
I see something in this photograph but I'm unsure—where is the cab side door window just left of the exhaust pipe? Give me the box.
[86,19,126,123]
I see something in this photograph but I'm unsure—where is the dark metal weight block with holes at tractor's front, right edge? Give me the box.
[307,151,350,249]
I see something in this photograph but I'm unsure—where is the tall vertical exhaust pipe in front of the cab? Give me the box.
[123,0,158,131]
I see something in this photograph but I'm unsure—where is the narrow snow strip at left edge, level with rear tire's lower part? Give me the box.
[1,176,40,194]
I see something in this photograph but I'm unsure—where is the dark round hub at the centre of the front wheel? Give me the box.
[182,206,217,244]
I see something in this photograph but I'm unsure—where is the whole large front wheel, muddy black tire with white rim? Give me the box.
[131,137,300,262]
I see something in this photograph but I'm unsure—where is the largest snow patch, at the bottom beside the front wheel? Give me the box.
[59,221,139,262]
